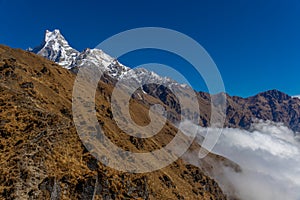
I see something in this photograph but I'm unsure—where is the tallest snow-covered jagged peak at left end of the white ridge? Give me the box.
[32,29,79,69]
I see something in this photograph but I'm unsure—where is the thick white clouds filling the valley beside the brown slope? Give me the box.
[180,121,300,200]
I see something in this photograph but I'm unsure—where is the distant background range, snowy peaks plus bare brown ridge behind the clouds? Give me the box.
[32,30,300,132]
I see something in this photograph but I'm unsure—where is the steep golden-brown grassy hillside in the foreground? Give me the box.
[0,46,227,199]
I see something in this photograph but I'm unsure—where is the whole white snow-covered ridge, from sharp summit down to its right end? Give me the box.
[29,29,186,88]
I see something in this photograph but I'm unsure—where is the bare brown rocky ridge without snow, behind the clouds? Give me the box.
[135,85,300,132]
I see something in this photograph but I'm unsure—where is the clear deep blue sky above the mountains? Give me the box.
[0,0,300,96]
